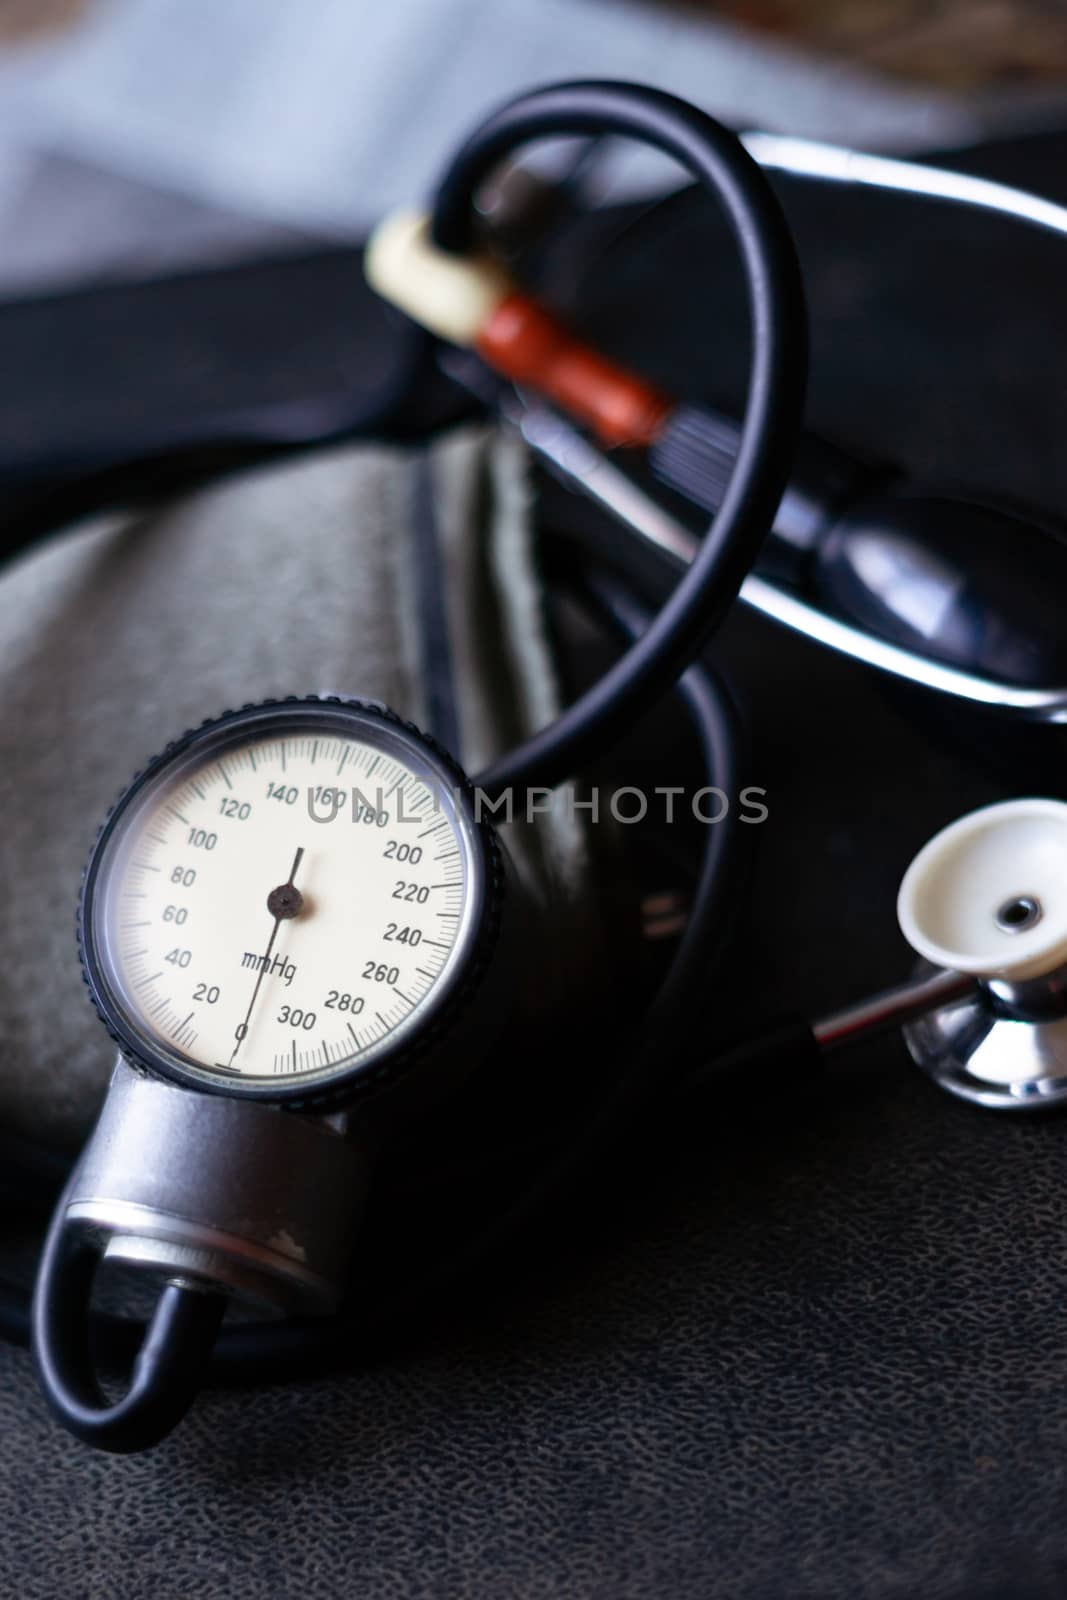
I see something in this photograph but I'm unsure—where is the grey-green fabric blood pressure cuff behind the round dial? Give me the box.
[0,427,600,1144]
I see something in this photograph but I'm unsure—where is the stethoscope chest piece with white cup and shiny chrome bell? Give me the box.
[897,800,1067,1110]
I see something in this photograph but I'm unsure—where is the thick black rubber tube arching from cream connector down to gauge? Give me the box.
[434,82,808,795]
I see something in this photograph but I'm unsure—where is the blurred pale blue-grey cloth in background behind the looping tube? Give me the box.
[0,0,1011,290]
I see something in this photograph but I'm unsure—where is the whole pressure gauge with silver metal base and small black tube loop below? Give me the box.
[34,699,511,1450]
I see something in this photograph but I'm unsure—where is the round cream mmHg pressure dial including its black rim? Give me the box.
[82,701,486,1098]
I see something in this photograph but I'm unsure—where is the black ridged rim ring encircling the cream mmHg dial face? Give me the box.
[77,696,502,1109]
